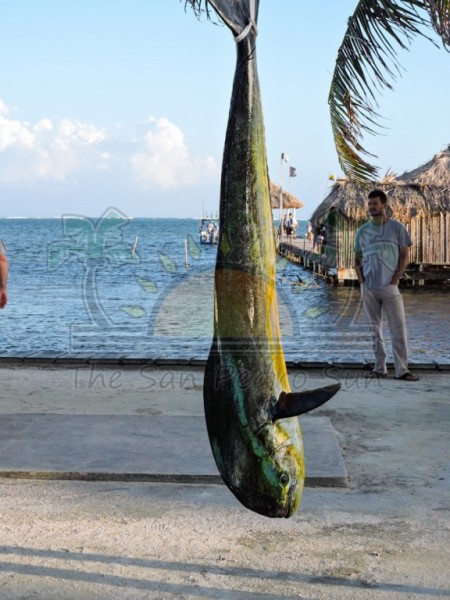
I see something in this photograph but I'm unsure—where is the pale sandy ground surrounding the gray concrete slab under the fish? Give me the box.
[0,366,450,600]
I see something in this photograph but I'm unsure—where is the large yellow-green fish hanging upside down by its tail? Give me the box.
[186,0,340,517]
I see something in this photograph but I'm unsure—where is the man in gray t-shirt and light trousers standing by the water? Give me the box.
[355,190,419,381]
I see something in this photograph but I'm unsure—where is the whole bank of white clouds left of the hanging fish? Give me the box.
[0,100,219,195]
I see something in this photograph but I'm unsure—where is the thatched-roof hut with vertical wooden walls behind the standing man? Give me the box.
[311,146,450,268]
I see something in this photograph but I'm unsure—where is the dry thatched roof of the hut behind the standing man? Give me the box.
[311,145,450,223]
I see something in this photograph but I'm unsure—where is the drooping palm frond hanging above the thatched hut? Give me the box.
[328,0,450,185]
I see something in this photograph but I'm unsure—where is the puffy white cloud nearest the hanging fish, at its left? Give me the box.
[130,117,217,190]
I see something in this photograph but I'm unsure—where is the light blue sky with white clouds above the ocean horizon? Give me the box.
[0,0,450,219]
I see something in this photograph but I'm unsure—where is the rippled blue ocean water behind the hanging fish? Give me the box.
[0,217,450,364]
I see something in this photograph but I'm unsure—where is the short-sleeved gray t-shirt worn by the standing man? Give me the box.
[355,219,412,290]
